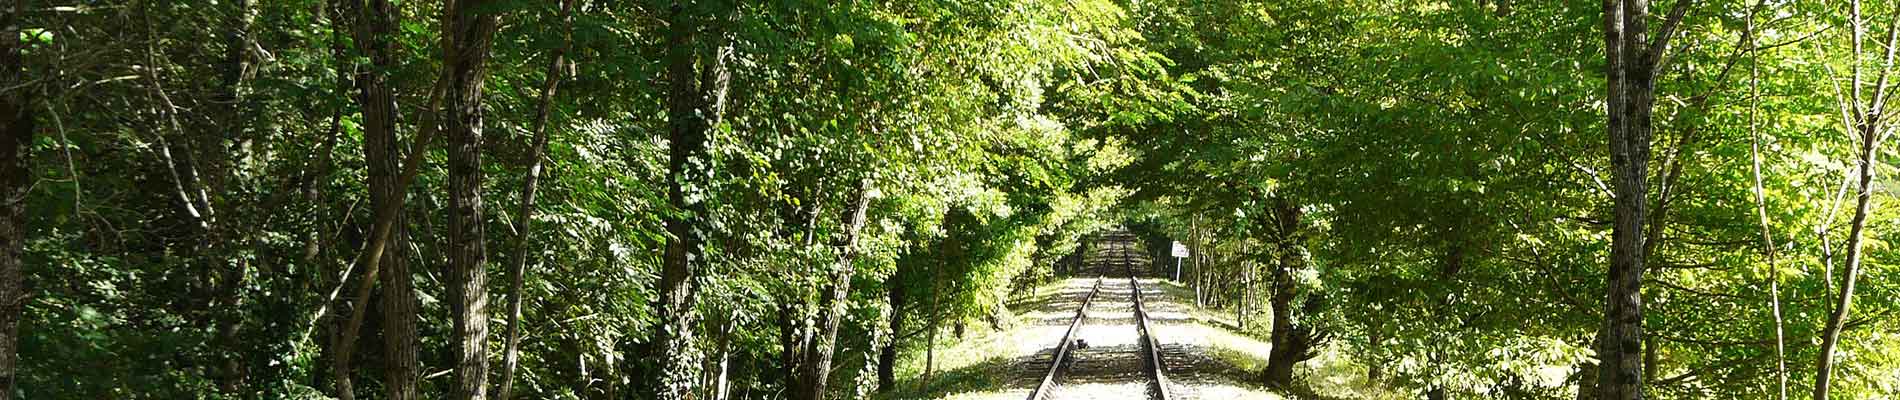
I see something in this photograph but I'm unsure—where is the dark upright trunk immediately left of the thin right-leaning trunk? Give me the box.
[443,0,498,400]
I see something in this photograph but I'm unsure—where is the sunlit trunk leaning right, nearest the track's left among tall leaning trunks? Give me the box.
[790,178,870,400]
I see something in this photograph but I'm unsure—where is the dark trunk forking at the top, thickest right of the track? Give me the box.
[1598,0,1695,400]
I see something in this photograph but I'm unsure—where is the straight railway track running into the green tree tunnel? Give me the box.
[1028,233,1170,400]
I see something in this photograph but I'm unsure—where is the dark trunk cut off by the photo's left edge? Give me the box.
[0,0,34,394]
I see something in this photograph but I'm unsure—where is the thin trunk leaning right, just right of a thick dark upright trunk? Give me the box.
[496,0,574,400]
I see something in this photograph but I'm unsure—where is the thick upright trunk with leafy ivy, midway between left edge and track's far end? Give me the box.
[654,2,707,400]
